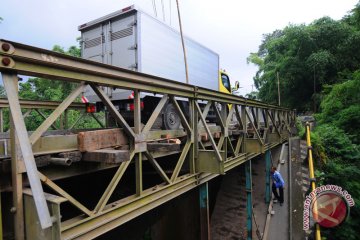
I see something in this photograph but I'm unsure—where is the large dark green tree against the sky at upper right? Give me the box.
[247,4,360,111]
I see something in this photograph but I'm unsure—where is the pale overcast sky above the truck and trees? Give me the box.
[0,0,358,94]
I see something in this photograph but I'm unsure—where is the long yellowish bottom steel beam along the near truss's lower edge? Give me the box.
[61,143,276,239]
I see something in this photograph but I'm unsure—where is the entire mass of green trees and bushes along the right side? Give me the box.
[253,2,360,240]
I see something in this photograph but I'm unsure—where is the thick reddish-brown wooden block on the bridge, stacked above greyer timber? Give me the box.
[78,128,128,152]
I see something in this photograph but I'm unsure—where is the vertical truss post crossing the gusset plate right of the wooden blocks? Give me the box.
[134,90,143,196]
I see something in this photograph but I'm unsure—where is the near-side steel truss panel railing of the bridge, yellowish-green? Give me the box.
[0,40,295,239]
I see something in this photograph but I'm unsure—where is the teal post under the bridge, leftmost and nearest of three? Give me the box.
[199,182,210,240]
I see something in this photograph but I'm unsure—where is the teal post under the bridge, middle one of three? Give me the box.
[245,160,252,240]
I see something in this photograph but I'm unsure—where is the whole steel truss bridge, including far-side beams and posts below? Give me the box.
[0,40,295,239]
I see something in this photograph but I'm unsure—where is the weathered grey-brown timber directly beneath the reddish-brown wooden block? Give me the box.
[83,149,130,164]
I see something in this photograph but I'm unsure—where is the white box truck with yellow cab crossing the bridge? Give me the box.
[78,6,235,129]
